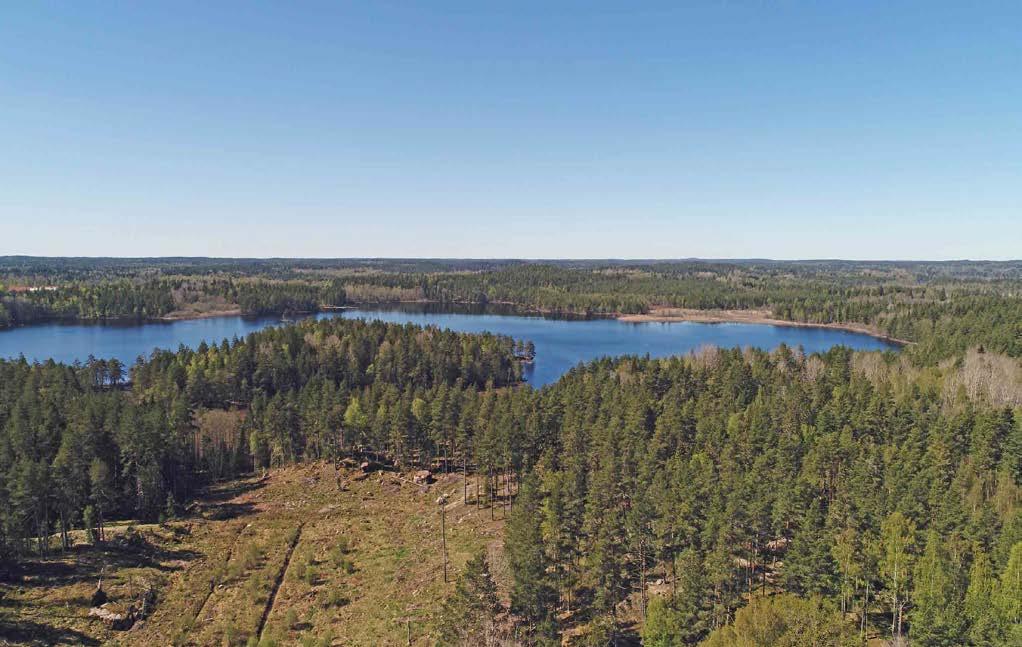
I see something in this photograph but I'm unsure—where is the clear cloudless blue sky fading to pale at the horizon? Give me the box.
[0,0,1022,259]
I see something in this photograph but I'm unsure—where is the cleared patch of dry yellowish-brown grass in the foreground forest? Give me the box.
[0,465,503,645]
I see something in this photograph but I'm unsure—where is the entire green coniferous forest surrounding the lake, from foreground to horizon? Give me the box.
[0,263,1022,646]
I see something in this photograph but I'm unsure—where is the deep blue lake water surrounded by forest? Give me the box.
[0,307,898,386]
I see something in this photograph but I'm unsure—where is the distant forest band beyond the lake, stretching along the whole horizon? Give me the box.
[0,257,1022,364]
